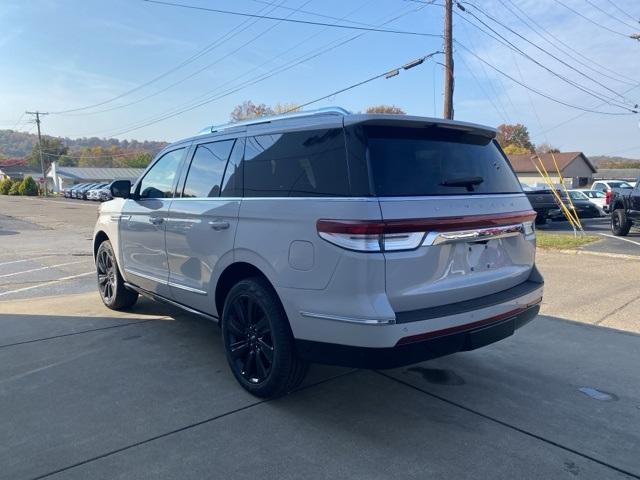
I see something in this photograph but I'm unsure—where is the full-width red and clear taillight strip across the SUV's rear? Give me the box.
[316,211,536,252]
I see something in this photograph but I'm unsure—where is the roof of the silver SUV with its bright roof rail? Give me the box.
[180,108,496,143]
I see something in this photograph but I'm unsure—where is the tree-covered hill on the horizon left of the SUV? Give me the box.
[0,130,167,158]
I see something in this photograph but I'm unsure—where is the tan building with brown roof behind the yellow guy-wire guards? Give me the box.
[508,152,598,188]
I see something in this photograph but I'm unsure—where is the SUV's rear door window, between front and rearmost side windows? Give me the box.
[182,140,234,197]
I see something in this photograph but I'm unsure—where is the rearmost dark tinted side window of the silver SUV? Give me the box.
[244,129,349,197]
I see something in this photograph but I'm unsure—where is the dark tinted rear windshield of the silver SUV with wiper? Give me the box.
[365,126,522,197]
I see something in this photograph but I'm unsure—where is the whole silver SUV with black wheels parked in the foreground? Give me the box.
[94,109,543,397]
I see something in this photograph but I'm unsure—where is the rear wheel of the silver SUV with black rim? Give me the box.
[221,277,309,398]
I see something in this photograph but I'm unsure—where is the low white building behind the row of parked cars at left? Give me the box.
[47,162,144,192]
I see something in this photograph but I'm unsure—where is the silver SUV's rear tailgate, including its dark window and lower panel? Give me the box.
[366,122,535,312]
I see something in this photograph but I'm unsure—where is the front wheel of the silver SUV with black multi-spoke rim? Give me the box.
[96,240,138,310]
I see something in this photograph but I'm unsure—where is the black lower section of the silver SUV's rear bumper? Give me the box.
[296,304,540,369]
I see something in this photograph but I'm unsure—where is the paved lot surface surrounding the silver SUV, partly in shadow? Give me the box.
[0,197,640,479]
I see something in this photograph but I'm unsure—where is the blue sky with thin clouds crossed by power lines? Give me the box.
[0,0,640,158]
